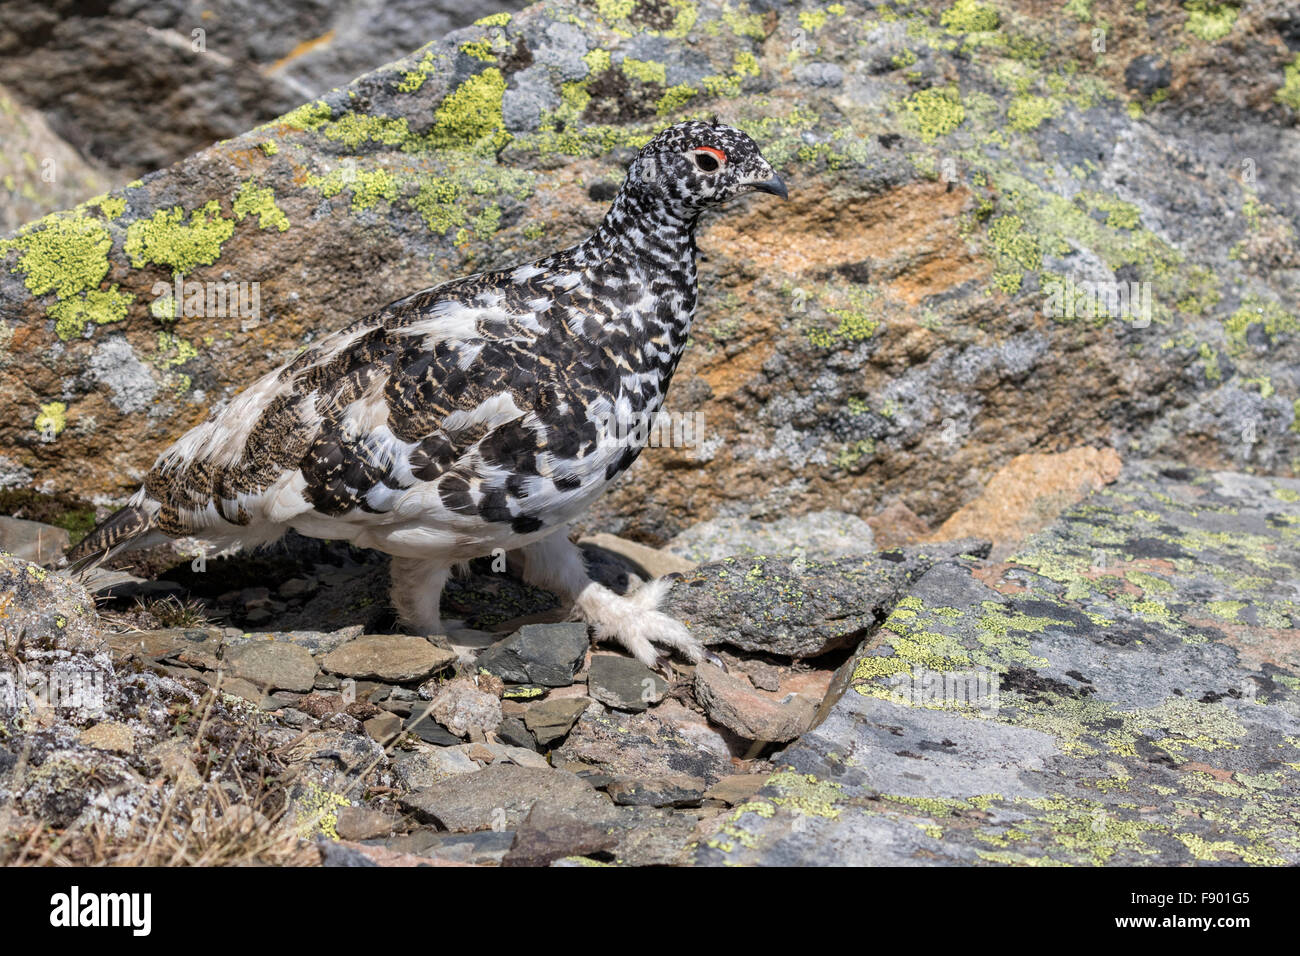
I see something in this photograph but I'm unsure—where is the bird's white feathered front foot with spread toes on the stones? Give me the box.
[573,578,714,670]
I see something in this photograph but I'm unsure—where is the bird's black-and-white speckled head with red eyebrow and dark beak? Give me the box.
[624,120,787,217]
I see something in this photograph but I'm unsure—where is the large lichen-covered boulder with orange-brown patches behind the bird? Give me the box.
[0,0,1300,541]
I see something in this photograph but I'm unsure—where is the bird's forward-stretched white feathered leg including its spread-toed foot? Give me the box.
[523,528,707,667]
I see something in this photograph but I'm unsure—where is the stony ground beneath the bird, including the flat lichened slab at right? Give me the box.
[0,457,1300,866]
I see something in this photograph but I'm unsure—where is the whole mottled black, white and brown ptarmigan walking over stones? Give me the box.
[66,118,788,666]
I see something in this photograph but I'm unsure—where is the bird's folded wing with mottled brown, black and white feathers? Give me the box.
[133,273,618,554]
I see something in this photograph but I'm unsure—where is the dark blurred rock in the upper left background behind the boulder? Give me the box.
[0,0,521,179]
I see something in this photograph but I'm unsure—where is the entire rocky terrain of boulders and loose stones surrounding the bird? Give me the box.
[0,0,1300,865]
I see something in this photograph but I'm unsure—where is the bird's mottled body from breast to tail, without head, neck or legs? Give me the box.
[69,201,694,557]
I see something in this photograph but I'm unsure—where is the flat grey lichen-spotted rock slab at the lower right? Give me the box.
[697,467,1300,866]
